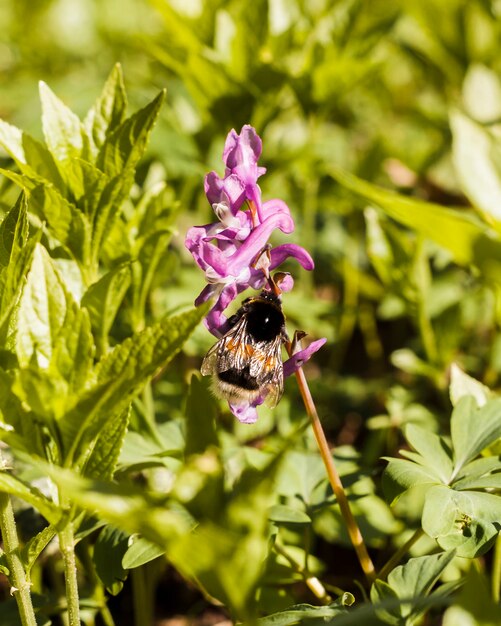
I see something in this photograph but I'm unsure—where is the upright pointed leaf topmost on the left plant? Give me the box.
[83,63,127,155]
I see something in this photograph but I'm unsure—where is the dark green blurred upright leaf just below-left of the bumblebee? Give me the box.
[185,374,218,456]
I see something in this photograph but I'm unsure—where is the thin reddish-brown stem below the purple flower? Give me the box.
[290,368,375,583]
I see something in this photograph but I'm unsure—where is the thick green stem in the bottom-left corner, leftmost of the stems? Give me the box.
[0,493,37,626]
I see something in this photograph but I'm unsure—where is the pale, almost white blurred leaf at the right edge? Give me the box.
[451,110,501,230]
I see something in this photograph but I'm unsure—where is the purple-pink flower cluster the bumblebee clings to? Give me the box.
[185,125,325,421]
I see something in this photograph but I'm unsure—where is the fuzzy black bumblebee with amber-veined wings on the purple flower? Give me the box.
[201,291,287,407]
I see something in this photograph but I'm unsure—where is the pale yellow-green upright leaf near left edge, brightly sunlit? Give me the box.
[16,244,66,368]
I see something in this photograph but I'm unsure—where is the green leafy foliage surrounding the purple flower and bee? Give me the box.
[0,0,501,626]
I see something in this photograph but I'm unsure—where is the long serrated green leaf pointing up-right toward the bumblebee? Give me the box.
[59,306,207,464]
